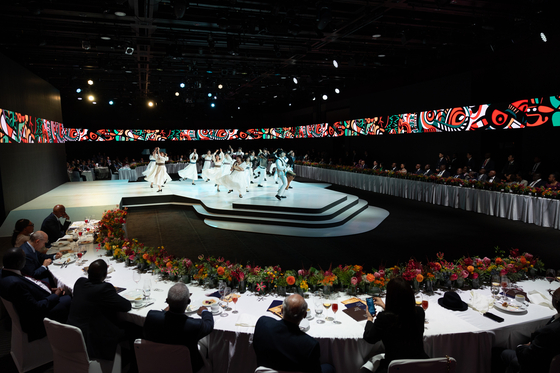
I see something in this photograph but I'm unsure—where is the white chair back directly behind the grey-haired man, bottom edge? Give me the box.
[134,339,193,373]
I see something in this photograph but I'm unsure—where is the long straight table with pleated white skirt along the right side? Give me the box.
[295,165,560,229]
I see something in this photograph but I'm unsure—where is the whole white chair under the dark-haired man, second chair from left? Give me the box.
[43,318,121,373]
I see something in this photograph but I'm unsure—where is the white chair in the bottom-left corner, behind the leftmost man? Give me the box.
[2,298,53,373]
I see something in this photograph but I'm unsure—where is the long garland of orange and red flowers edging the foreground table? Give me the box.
[97,208,544,293]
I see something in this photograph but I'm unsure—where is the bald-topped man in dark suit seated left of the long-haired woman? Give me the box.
[253,294,334,373]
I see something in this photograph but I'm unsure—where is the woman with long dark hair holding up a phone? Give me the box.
[364,277,428,372]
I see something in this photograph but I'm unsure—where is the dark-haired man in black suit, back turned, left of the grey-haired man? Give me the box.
[68,259,133,360]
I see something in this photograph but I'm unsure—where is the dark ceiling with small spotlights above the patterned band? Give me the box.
[0,0,558,127]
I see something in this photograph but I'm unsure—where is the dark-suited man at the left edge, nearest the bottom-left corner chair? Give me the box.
[0,248,71,342]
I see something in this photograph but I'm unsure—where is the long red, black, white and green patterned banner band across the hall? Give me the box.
[0,96,560,143]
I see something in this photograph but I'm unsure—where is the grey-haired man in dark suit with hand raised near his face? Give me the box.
[144,283,214,372]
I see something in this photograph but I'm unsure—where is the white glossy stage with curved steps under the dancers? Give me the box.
[0,179,389,237]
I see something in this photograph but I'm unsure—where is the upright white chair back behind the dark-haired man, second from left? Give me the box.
[43,318,89,372]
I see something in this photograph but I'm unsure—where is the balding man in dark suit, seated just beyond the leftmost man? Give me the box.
[21,231,62,287]
